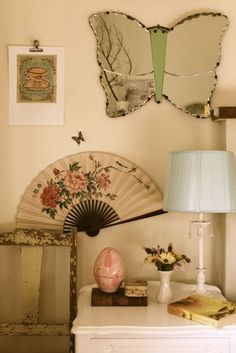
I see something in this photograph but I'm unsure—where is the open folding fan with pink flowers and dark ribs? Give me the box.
[16,152,164,236]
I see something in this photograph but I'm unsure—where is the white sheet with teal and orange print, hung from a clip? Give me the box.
[8,46,64,125]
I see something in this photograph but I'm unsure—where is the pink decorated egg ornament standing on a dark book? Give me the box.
[94,247,125,293]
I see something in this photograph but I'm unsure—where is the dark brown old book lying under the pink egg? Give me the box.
[91,288,148,306]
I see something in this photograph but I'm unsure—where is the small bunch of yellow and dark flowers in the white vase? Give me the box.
[144,243,191,271]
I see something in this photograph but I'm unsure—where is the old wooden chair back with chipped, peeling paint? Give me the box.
[0,229,77,353]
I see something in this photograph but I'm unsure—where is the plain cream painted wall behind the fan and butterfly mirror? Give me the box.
[0,0,236,338]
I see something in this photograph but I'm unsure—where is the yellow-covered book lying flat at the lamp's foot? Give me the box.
[167,295,236,328]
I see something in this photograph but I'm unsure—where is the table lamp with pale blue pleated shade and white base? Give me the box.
[163,151,236,295]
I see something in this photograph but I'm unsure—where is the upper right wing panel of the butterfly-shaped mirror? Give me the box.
[165,13,228,76]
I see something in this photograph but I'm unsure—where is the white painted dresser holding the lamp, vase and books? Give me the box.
[72,282,236,353]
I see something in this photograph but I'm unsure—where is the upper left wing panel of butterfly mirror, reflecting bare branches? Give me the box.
[89,12,153,76]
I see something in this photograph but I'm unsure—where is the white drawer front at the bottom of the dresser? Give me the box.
[89,338,230,353]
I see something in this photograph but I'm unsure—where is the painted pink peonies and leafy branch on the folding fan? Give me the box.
[33,154,150,218]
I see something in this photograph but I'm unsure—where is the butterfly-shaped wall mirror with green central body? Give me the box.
[89,11,228,118]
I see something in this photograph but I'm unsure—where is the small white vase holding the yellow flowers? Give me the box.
[157,271,173,304]
